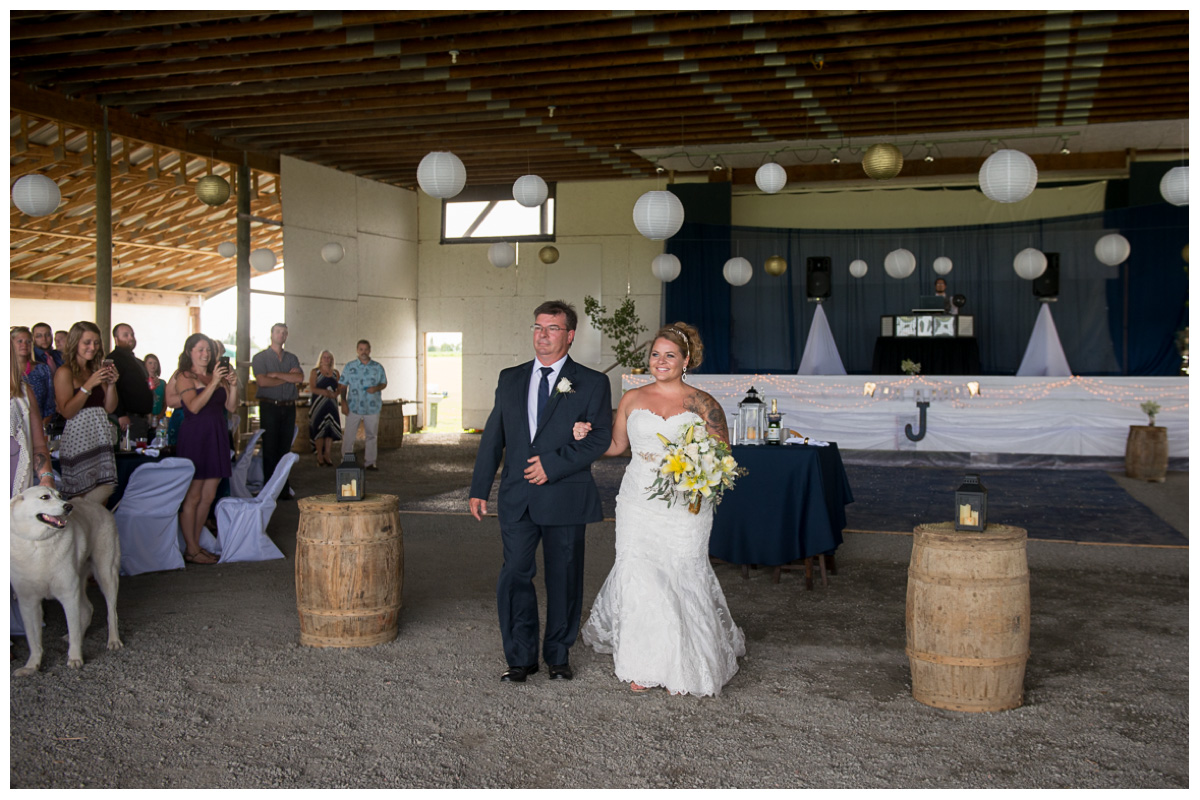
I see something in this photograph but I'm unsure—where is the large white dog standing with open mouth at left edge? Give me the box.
[8,486,122,676]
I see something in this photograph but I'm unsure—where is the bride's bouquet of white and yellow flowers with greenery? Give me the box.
[648,422,746,513]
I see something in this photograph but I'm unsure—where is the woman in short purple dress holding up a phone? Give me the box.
[167,333,238,564]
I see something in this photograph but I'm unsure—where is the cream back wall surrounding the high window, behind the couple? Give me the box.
[418,180,662,428]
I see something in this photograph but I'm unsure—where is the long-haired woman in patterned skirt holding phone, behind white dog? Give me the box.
[54,321,120,505]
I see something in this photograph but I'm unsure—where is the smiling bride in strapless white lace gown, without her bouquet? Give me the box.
[576,323,745,696]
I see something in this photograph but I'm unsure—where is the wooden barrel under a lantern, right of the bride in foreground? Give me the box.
[905,522,1030,711]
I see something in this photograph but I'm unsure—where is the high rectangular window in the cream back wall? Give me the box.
[442,184,554,245]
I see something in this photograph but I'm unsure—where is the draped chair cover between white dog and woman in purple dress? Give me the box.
[113,458,196,575]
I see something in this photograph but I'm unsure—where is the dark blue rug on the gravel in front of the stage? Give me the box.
[401,458,1188,547]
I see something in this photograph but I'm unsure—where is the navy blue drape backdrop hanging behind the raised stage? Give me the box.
[664,203,1188,375]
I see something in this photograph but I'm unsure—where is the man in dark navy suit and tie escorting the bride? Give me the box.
[469,300,612,682]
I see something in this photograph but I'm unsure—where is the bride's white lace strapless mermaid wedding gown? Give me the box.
[583,409,745,694]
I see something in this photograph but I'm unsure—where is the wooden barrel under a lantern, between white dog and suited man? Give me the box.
[296,494,404,648]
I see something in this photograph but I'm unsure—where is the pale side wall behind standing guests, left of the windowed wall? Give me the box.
[281,157,419,407]
